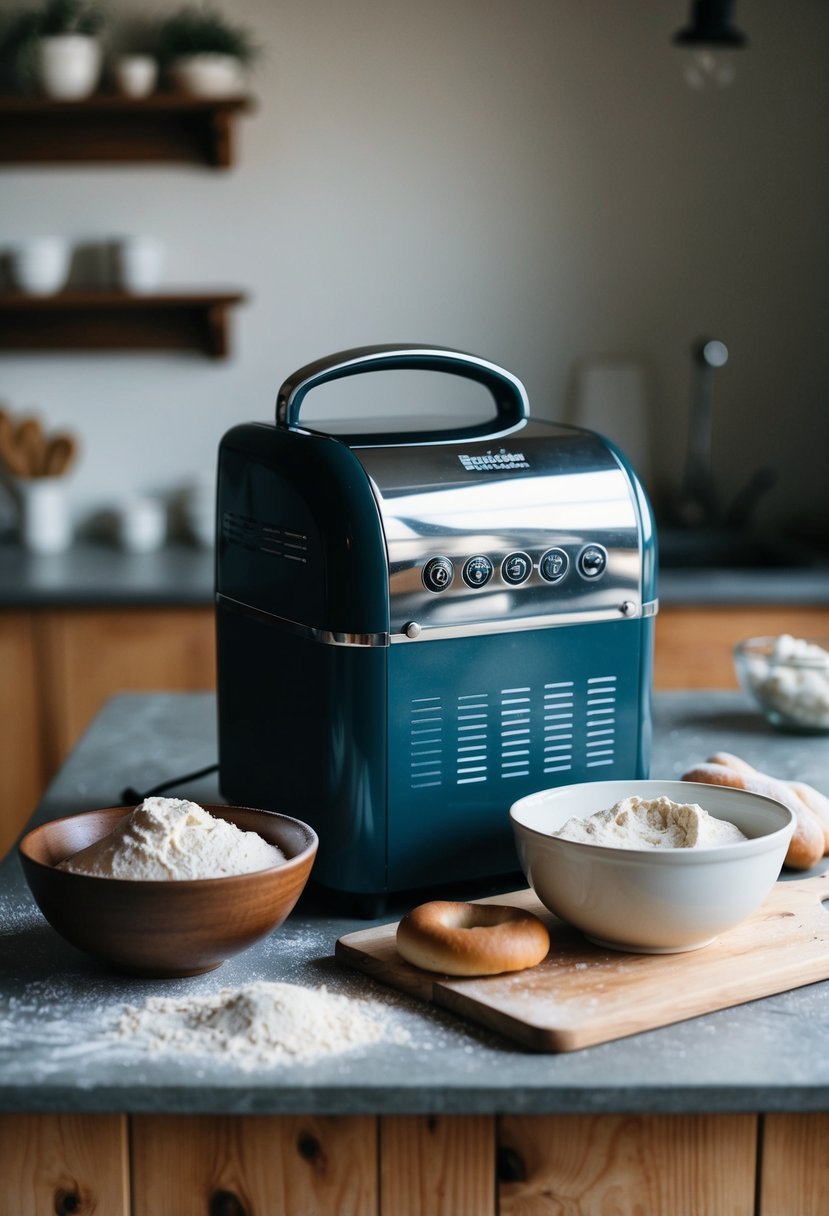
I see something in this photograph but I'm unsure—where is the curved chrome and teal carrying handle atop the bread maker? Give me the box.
[276,345,530,438]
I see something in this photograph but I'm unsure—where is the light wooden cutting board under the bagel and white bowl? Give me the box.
[335,872,829,1052]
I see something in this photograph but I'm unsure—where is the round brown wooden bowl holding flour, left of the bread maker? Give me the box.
[18,806,318,976]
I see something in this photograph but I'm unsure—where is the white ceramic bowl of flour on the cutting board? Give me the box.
[509,781,794,955]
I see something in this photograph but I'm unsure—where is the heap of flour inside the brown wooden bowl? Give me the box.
[57,798,286,880]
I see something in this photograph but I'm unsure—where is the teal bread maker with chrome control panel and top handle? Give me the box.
[216,347,656,913]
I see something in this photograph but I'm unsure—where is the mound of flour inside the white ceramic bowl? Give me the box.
[552,795,746,849]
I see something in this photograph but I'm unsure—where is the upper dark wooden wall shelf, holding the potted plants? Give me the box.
[0,92,253,169]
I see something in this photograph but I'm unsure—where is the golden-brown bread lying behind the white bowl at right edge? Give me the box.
[682,751,829,869]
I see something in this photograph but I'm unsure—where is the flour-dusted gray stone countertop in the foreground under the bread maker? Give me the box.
[0,692,829,1114]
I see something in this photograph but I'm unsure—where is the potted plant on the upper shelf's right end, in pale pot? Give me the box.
[158,7,256,97]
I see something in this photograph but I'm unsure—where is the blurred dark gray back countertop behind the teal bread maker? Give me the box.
[0,541,829,608]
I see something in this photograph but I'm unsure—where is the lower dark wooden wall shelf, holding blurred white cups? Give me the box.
[0,291,244,359]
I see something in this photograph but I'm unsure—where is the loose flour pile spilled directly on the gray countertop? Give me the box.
[117,980,410,1069]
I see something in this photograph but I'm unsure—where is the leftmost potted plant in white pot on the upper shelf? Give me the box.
[2,0,103,101]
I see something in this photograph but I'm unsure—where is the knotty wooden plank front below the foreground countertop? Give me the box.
[0,1114,829,1216]
